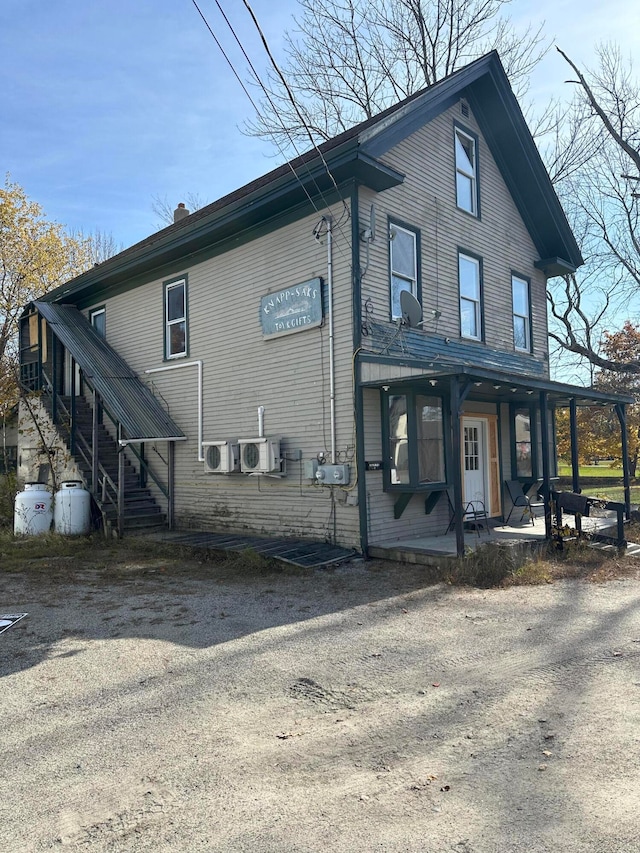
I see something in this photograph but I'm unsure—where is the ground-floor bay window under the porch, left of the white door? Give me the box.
[385,390,446,489]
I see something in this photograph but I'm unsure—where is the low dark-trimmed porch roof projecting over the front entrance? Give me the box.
[362,364,635,407]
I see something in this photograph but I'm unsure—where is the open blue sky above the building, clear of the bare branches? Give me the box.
[0,0,640,246]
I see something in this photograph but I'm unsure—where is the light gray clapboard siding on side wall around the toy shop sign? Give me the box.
[88,206,359,547]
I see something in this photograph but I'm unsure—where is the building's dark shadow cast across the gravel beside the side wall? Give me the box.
[0,538,448,677]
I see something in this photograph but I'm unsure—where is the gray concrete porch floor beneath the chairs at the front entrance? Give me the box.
[369,512,640,565]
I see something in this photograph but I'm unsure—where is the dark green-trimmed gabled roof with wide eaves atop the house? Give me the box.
[44,51,583,302]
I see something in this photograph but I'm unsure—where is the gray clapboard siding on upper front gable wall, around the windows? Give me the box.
[360,100,548,374]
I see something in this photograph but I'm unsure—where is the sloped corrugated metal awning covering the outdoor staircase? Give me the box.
[27,301,186,442]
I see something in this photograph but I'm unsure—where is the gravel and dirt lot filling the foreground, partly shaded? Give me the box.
[0,546,640,853]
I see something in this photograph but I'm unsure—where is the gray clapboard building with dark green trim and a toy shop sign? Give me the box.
[21,53,624,553]
